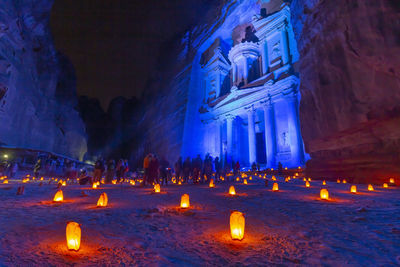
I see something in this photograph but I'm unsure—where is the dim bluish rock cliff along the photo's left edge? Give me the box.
[0,0,86,158]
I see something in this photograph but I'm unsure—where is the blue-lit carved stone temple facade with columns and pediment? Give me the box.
[182,1,306,167]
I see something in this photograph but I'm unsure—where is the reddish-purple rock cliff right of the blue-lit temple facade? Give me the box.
[291,0,400,182]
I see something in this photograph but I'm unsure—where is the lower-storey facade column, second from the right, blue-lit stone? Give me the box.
[263,99,276,168]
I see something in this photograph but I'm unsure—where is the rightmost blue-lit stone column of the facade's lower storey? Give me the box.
[285,93,304,166]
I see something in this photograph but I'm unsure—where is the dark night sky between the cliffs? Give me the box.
[51,0,219,108]
